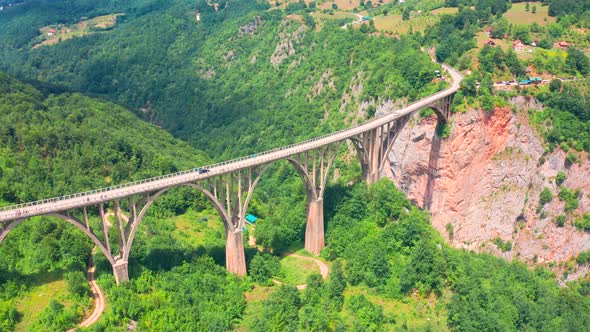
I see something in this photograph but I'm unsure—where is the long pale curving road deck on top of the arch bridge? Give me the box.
[0,65,462,222]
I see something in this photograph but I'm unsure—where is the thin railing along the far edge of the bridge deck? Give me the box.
[0,66,462,212]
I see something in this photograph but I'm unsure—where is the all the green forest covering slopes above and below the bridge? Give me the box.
[0,0,590,331]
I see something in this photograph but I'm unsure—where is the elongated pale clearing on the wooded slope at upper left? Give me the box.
[33,13,124,48]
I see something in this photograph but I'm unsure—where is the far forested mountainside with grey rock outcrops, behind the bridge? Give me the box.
[0,1,440,159]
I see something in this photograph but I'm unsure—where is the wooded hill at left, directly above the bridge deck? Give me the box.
[0,74,207,203]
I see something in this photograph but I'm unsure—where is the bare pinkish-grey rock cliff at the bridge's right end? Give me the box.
[388,98,590,278]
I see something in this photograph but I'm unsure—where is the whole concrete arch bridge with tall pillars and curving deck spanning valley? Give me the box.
[0,65,462,283]
